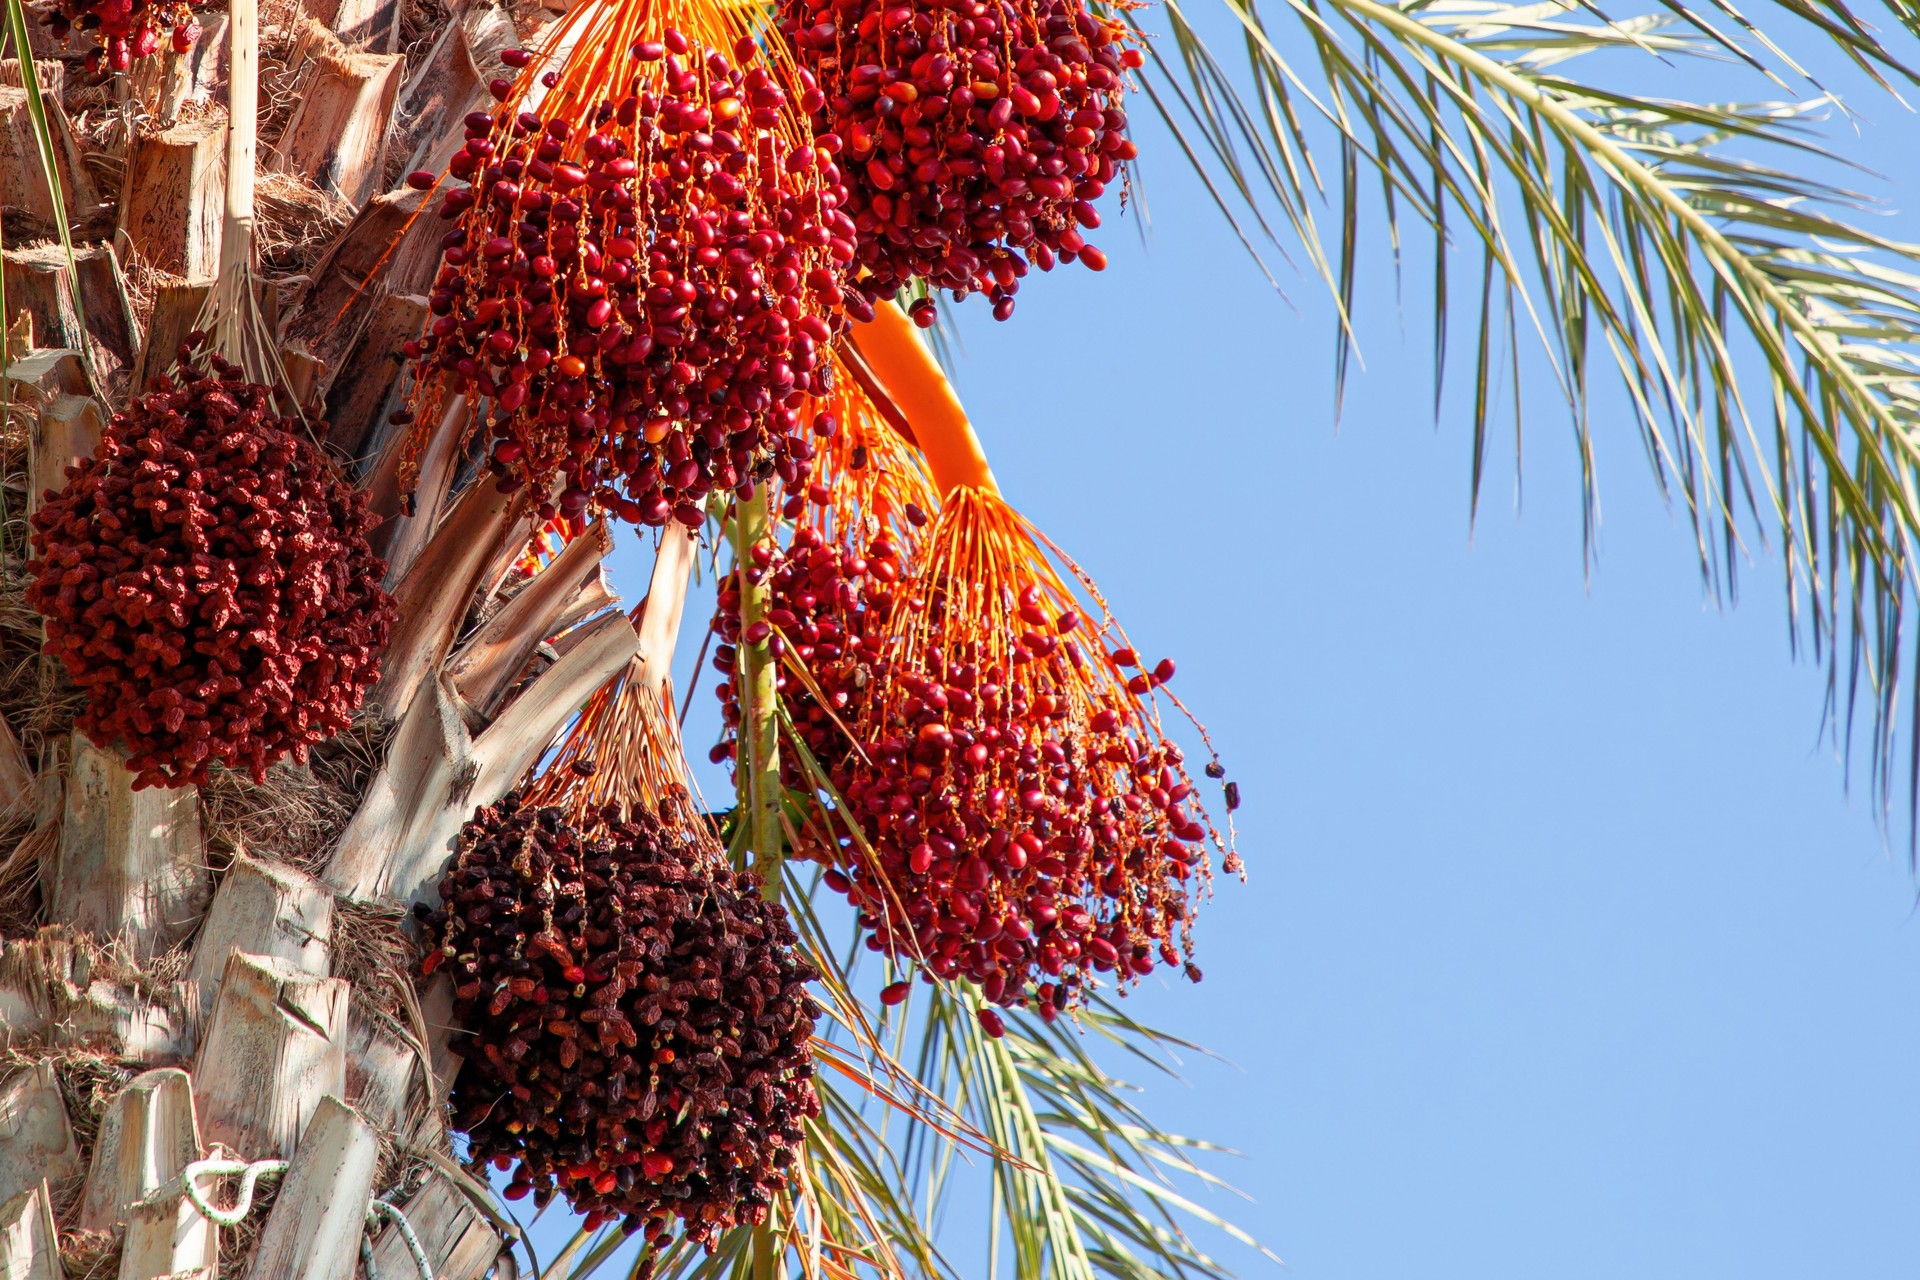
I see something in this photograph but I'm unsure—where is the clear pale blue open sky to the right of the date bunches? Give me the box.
[560,5,1920,1280]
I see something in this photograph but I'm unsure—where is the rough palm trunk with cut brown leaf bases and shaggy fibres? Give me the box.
[0,0,645,1280]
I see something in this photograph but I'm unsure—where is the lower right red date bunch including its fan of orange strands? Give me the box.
[828,486,1238,1034]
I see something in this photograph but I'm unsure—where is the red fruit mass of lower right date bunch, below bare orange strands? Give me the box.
[833,589,1212,1032]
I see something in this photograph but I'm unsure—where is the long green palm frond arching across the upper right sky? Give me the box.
[1121,0,1920,832]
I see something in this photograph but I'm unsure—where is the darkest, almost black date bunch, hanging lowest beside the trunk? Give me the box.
[417,790,820,1247]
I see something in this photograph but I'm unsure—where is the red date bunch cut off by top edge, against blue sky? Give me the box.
[781,0,1140,324]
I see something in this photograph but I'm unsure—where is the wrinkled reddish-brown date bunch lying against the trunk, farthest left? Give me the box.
[27,347,396,787]
